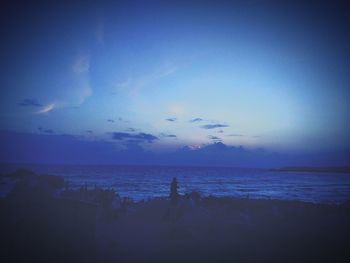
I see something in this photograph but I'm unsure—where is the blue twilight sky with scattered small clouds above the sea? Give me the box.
[0,0,350,167]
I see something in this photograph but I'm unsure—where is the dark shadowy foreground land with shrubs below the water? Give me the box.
[0,170,350,262]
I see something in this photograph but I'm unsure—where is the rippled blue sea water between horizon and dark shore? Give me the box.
[2,165,350,203]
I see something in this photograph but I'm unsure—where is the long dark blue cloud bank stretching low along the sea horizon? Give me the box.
[0,130,350,168]
